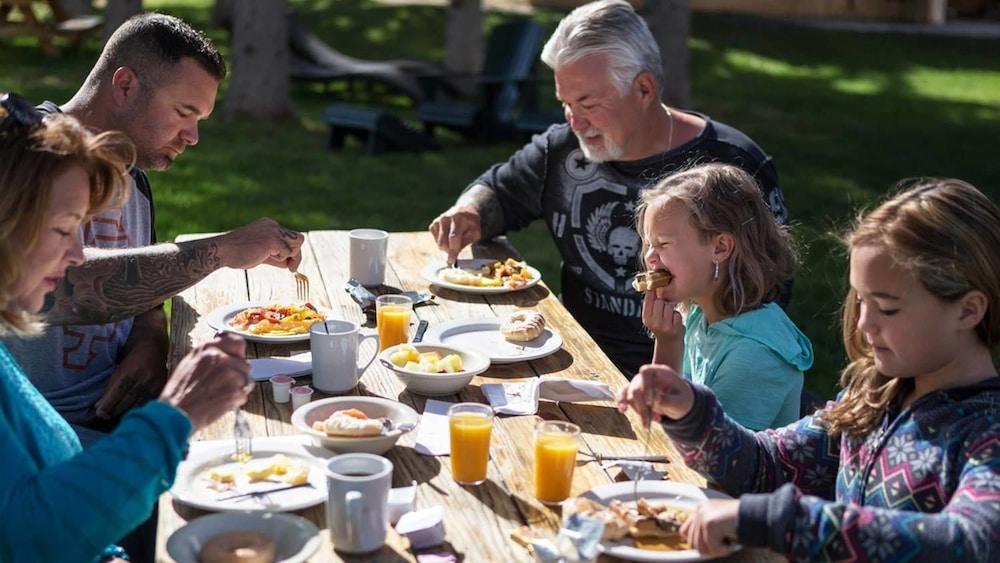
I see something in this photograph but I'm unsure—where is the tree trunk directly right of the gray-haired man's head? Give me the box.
[643,0,691,108]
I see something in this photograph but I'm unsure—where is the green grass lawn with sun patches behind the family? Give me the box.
[0,0,1000,397]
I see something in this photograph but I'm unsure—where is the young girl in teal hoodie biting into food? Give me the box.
[637,164,813,430]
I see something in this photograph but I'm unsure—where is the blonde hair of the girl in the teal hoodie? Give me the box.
[636,164,795,317]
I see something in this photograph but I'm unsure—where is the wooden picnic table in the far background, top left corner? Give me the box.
[0,0,104,56]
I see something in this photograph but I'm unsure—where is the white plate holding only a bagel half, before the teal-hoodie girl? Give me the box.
[424,309,562,364]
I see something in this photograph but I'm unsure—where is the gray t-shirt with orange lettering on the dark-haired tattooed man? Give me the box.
[4,102,156,425]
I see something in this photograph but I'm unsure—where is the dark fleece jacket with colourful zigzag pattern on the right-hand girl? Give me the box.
[663,378,1000,563]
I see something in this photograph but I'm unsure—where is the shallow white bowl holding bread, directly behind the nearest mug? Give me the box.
[292,396,420,454]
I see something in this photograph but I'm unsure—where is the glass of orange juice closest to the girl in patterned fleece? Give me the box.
[535,420,580,504]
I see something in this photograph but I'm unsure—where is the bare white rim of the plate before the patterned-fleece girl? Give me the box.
[581,481,739,561]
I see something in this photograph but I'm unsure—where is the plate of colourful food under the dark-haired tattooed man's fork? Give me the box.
[208,302,329,344]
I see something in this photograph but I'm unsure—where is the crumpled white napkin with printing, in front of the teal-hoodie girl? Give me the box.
[482,376,615,415]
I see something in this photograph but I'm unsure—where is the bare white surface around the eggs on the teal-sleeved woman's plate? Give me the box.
[170,436,329,512]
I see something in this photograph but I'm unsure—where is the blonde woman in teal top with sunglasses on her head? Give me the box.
[0,94,249,561]
